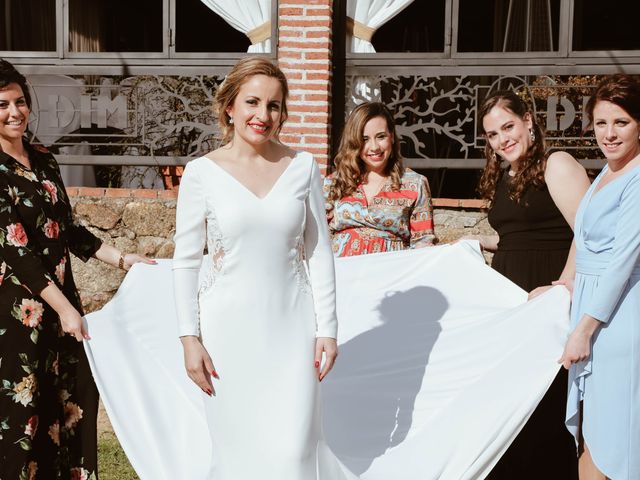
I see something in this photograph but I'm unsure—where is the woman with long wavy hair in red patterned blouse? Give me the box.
[324,102,436,257]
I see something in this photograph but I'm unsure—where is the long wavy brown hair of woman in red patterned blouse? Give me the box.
[329,102,404,201]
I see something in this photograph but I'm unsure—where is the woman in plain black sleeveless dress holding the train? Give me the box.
[468,91,589,480]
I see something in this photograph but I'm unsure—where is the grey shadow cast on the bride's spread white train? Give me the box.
[322,287,449,475]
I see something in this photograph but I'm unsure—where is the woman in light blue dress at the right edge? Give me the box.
[560,75,640,480]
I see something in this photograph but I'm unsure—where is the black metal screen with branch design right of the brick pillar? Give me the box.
[346,71,601,168]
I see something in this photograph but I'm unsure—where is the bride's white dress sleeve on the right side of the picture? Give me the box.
[304,161,338,338]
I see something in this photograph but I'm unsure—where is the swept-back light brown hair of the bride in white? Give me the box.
[214,57,289,143]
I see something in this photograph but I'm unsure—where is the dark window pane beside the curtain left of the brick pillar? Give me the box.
[176,0,251,52]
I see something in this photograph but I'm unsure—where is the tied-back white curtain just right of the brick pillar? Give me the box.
[347,0,413,53]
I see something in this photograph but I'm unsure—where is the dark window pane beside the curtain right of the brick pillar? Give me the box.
[371,0,445,52]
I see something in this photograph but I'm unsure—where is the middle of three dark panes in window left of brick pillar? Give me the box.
[69,0,163,52]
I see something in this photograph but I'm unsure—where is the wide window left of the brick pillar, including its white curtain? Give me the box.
[0,0,277,58]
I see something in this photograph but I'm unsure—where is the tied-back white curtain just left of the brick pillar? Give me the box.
[201,0,271,53]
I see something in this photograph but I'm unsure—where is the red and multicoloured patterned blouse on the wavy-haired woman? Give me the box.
[324,168,436,257]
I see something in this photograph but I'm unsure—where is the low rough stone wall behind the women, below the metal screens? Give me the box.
[69,188,492,312]
